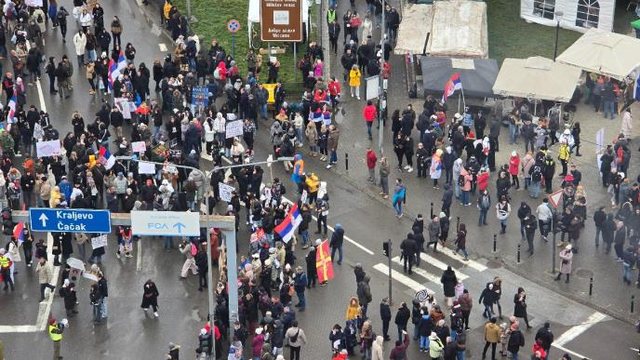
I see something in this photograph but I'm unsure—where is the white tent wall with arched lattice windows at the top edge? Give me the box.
[520,0,616,32]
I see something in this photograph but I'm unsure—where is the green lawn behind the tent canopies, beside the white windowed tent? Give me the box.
[486,0,581,64]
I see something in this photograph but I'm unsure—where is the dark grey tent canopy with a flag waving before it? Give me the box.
[420,56,498,97]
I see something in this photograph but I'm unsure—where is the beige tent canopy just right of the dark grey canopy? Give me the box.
[493,56,582,102]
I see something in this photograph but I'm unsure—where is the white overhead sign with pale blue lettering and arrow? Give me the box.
[131,211,200,236]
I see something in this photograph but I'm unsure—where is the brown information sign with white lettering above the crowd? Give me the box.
[260,0,304,42]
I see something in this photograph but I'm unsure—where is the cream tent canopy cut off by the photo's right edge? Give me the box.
[558,29,640,80]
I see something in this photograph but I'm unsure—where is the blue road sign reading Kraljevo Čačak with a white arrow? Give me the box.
[29,208,111,234]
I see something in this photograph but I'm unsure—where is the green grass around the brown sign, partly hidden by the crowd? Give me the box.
[174,0,316,91]
